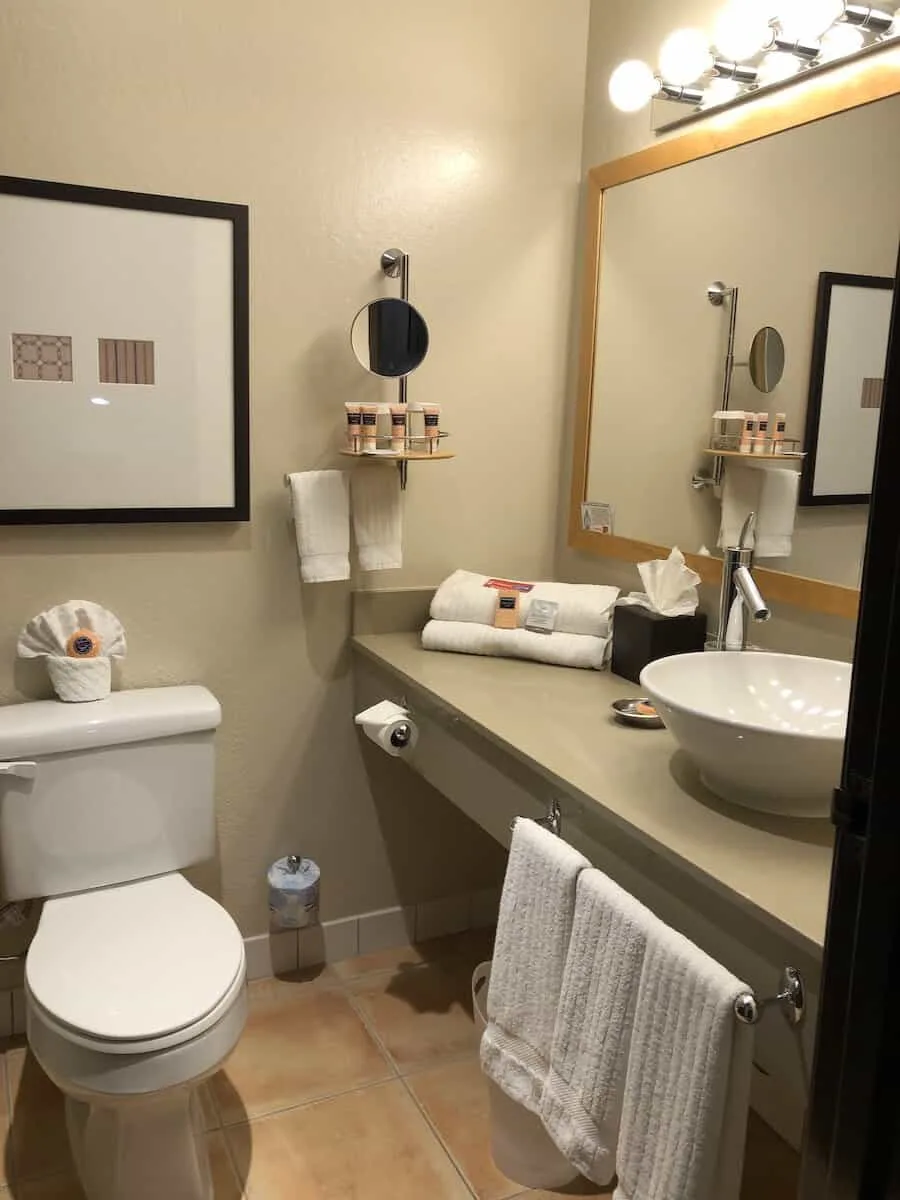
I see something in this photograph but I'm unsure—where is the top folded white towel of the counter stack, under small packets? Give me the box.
[431,571,619,637]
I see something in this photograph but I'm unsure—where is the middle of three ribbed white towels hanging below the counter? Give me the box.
[541,869,658,1187]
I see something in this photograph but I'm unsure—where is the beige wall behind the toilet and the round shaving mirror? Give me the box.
[0,0,588,934]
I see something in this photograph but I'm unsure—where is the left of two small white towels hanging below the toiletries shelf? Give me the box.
[288,470,350,583]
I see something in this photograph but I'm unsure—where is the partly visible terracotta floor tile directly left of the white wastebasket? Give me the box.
[407,1058,522,1200]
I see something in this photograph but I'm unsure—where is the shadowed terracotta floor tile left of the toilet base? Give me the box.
[6,1050,72,1180]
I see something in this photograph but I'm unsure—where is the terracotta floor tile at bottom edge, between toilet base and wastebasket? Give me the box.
[227,1080,470,1200]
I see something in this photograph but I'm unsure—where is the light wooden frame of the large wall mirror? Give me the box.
[569,44,900,619]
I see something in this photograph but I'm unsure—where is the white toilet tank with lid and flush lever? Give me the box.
[0,686,222,900]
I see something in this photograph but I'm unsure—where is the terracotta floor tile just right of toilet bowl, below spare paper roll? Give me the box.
[210,979,392,1124]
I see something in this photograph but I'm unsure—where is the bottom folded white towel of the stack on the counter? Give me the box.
[422,620,610,671]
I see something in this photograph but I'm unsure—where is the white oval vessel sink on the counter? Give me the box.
[641,652,852,817]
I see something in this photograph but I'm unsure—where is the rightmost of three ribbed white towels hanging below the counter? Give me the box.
[613,922,752,1200]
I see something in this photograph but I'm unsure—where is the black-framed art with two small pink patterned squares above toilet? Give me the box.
[0,176,250,524]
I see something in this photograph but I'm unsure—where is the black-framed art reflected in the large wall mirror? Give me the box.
[800,271,894,505]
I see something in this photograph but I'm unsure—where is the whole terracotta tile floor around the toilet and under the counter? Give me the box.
[0,934,797,1200]
